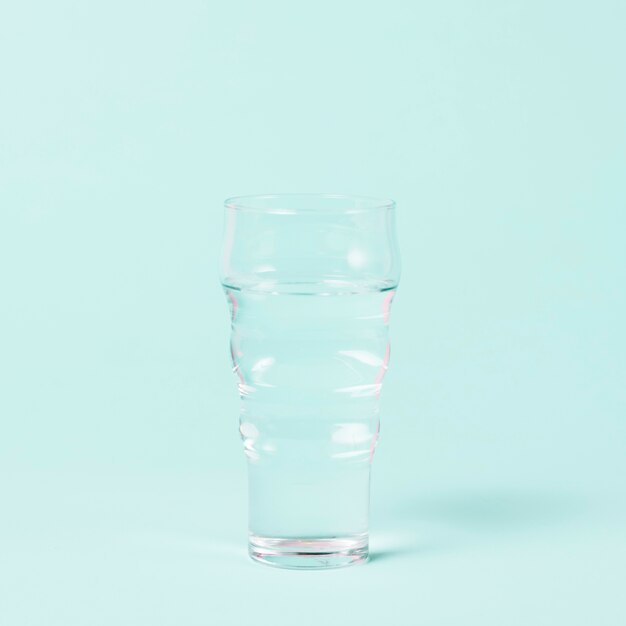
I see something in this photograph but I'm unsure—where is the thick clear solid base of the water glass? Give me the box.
[248,533,369,569]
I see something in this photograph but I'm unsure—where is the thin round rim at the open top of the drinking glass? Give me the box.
[224,193,396,215]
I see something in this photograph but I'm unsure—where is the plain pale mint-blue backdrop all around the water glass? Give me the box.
[0,0,626,626]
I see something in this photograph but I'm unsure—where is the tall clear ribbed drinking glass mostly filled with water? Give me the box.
[220,194,400,568]
